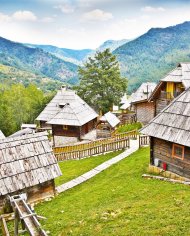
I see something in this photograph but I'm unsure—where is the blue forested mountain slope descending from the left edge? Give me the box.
[0,37,78,84]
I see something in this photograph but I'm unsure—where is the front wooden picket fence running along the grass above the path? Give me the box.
[55,138,130,161]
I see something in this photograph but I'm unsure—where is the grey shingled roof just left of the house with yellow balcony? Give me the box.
[130,82,156,103]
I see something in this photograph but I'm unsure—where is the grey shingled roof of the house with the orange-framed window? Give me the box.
[141,88,190,147]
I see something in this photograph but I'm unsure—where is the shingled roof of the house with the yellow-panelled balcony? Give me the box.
[149,62,190,100]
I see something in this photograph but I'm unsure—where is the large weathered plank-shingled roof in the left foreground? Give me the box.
[0,133,61,196]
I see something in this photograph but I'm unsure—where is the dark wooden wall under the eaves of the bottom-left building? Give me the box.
[0,180,55,212]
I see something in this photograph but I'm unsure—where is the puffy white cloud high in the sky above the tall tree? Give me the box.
[83,9,113,21]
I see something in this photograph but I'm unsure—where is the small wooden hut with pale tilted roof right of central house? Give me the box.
[96,111,120,138]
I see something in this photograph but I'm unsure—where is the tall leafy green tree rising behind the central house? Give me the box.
[77,49,127,113]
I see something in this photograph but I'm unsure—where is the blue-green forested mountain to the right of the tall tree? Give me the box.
[113,22,190,92]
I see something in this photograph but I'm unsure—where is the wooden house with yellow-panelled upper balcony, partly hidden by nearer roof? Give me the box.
[149,63,190,115]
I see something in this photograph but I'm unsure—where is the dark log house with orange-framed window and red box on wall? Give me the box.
[141,89,190,178]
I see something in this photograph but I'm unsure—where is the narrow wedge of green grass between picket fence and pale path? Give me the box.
[55,151,122,186]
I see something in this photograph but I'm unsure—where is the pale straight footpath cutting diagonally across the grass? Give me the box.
[56,139,139,193]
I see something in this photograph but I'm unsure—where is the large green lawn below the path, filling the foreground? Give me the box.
[35,148,190,236]
